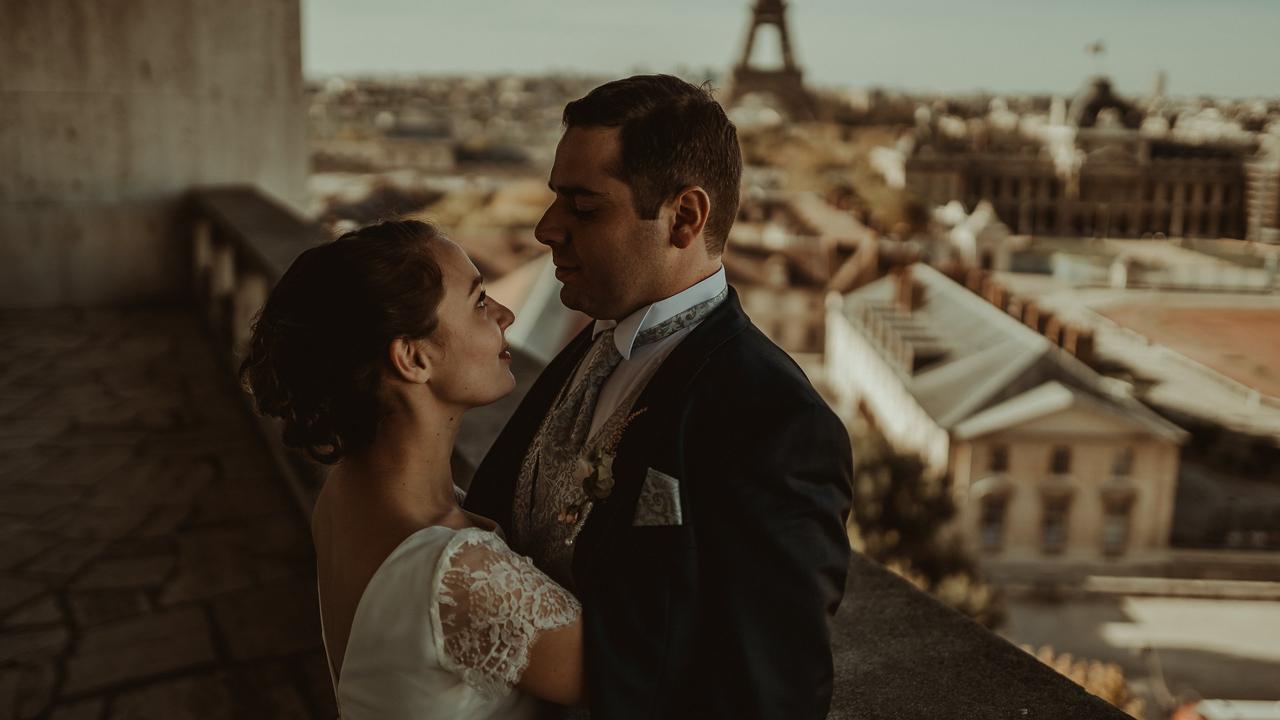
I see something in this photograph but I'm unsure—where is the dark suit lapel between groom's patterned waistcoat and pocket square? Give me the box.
[573,288,750,573]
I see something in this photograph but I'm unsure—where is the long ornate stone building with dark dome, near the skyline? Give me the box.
[906,78,1275,240]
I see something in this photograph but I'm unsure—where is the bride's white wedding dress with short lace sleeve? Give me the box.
[321,525,581,720]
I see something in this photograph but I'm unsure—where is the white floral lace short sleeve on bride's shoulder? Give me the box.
[433,530,582,698]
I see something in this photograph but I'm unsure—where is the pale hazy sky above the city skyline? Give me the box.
[302,0,1280,96]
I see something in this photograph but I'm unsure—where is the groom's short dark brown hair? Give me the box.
[564,76,742,254]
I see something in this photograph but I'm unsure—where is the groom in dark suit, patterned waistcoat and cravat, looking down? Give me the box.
[466,76,851,720]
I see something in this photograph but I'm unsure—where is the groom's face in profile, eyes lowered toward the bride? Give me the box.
[534,127,669,320]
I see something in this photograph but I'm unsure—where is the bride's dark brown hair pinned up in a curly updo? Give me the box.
[239,220,444,464]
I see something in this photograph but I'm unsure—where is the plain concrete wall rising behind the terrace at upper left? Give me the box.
[0,0,307,307]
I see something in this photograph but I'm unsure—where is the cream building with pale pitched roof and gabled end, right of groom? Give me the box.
[826,264,1185,566]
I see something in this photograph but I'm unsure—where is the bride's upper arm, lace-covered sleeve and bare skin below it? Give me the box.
[434,532,584,705]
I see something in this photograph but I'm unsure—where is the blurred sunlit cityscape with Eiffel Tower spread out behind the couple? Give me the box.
[307,0,1280,720]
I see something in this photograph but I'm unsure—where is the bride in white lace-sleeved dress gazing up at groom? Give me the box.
[241,220,584,720]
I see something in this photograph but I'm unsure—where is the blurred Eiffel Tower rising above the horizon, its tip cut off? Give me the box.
[727,0,817,120]
